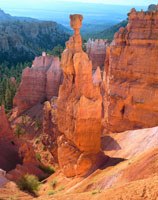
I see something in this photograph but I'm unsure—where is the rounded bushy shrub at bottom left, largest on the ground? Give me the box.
[17,174,40,195]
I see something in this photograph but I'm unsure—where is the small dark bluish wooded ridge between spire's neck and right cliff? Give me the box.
[93,20,128,40]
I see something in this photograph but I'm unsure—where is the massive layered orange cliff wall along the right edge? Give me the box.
[104,9,158,132]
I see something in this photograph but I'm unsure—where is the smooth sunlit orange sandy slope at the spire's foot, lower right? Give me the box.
[0,127,158,200]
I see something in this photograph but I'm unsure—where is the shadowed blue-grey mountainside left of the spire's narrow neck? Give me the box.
[0,10,69,64]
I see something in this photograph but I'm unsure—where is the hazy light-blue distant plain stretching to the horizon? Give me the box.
[0,0,147,37]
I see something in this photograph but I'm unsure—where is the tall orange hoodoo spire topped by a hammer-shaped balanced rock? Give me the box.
[57,15,104,177]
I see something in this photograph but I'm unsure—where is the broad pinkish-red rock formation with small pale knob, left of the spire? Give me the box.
[14,53,62,114]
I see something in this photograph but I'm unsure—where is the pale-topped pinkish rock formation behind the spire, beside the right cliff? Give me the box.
[86,39,109,70]
